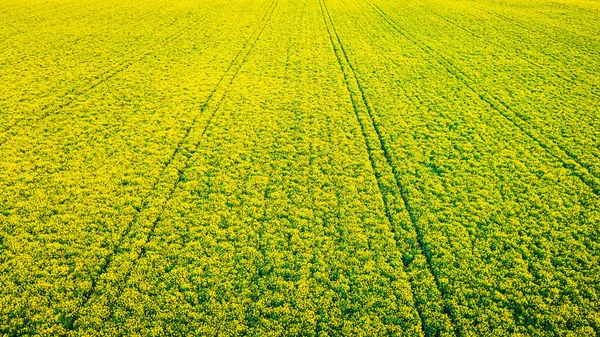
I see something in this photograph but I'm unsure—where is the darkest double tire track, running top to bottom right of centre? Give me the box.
[319,0,458,335]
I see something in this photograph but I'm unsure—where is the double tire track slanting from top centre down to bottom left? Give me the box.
[67,0,278,330]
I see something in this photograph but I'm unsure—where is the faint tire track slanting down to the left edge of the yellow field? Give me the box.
[0,5,214,146]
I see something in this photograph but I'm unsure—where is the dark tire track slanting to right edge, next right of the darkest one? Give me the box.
[373,4,600,196]
